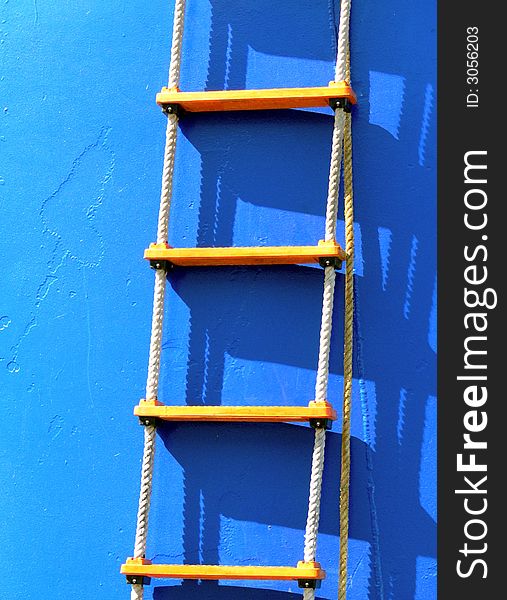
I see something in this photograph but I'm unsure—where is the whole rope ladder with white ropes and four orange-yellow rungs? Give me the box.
[121,0,356,600]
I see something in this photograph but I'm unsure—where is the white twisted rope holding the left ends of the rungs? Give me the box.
[130,0,185,600]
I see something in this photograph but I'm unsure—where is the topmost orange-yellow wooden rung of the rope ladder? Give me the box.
[157,81,357,112]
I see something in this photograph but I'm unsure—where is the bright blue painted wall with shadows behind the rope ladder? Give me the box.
[0,0,436,600]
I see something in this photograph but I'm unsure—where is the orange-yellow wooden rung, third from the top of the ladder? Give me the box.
[134,400,336,423]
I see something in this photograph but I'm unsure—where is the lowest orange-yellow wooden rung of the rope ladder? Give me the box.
[121,558,326,581]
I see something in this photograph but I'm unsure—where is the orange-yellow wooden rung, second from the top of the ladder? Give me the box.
[144,240,346,267]
